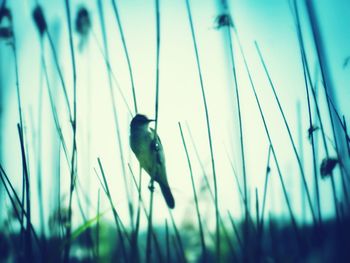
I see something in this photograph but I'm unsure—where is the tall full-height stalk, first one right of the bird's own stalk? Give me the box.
[186,0,220,262]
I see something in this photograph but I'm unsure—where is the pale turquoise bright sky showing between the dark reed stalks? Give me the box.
[0,0,350,235]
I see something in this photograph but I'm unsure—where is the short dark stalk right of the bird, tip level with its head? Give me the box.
[179,122,207,262]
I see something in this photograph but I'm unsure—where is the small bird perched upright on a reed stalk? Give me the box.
[130,114,175,208]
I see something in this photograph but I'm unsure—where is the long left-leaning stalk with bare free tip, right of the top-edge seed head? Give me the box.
[254,42,321,225]
